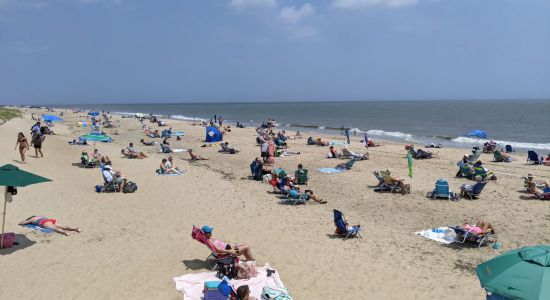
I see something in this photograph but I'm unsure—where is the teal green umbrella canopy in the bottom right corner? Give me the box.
[476,245,550,300]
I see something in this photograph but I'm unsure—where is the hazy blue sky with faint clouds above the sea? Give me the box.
[0,0,550,104]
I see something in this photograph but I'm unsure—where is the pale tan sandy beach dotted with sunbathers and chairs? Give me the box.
[0,110,550,299]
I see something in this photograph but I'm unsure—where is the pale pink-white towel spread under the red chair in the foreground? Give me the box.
[174,264,284,300]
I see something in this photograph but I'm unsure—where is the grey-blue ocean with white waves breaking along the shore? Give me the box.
[55,100,550,154]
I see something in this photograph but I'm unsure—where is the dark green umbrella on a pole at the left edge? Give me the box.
[0,164,51,249]
